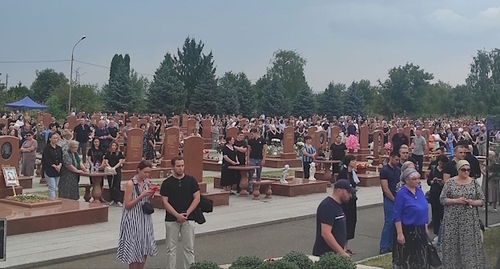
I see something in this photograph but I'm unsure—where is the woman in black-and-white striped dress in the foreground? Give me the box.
[117,161,158,269]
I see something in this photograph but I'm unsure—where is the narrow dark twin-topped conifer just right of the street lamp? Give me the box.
[103,54,135,111]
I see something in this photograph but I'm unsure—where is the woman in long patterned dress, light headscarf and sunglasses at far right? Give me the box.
[439,160,488,269]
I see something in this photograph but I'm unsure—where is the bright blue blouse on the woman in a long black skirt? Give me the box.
[393,186,429,226]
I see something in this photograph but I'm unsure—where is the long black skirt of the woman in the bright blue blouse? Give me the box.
[392,225,431,269]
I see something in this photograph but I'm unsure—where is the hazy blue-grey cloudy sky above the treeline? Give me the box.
[0,0,500,91]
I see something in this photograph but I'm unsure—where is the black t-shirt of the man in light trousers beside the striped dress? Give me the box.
[160,175,200,221]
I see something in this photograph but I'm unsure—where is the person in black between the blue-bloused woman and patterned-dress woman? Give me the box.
[427,155,448,235]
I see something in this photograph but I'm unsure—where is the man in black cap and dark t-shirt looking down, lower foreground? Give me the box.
[312,179,356,257]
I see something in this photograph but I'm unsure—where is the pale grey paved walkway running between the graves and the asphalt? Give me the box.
[0,172,428,268]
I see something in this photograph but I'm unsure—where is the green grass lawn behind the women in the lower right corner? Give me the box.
[363,226,500,269]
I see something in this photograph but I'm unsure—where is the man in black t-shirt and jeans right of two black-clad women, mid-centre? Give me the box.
[248,129,267,193]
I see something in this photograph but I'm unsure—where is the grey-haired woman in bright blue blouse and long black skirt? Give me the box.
[392,169,430,269]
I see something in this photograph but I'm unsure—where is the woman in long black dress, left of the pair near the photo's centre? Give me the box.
[220,136,240,195]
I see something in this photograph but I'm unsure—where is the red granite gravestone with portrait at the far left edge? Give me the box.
[0,135,23,198]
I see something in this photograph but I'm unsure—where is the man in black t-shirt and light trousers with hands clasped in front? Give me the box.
[160,156,200,268]
